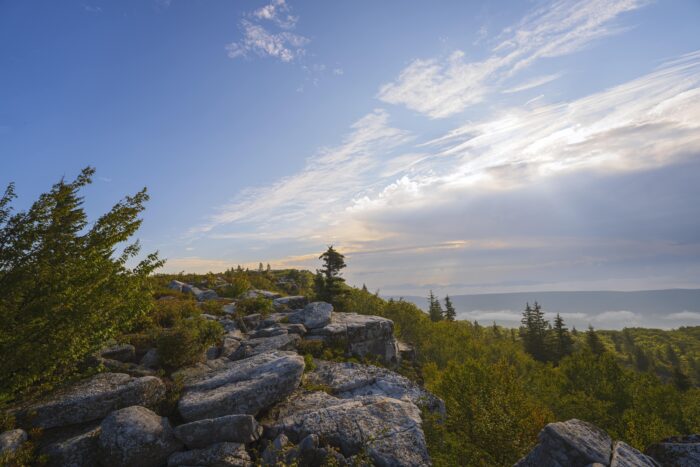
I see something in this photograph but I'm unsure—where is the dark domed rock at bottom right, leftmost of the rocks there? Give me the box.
[516,419,612,467]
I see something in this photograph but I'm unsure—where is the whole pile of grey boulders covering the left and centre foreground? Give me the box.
[0,294,445,467]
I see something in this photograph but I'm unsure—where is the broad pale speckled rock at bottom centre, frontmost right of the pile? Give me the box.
[268,392,430,466]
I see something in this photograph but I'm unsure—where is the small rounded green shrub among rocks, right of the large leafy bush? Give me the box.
[156,318,224,371]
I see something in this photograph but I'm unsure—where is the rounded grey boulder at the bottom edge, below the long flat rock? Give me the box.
[99,406,182,467]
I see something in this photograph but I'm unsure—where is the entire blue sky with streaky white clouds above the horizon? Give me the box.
[0,0,700,295]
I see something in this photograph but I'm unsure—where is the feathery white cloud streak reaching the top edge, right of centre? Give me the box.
[377,0,647,118]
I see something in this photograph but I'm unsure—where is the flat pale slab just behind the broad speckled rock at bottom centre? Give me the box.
[306,360,445,415]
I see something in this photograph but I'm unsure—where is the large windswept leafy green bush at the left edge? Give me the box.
[0,168,162,400]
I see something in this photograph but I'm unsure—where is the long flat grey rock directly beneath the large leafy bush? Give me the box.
[18,373,165,429]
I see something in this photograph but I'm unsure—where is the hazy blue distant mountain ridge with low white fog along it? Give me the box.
[393,289,700,329]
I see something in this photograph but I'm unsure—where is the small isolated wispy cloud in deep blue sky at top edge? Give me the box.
[226,0,310,62]
